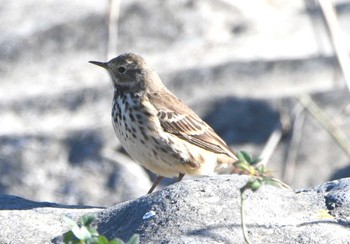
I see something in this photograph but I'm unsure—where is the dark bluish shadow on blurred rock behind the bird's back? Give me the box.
[204,98,279,144]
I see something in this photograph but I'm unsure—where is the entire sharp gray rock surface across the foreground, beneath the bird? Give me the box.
[0,175,350,244]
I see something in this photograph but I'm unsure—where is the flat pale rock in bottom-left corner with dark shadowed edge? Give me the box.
[0,194,102,244]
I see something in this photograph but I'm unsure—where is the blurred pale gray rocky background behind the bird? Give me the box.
[0,0,350,206]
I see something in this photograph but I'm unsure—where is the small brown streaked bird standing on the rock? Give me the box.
[89,53,238,194]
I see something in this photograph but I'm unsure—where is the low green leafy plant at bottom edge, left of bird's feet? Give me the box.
[63,215,140,244]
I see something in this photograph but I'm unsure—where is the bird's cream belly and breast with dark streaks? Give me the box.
[112,97,227,177]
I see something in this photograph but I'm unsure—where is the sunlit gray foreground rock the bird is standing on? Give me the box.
[96,175,350,243]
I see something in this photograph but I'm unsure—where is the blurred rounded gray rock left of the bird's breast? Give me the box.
[0,133,151,206]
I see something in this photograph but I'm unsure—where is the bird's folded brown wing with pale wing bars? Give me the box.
[150,90,237,159]
